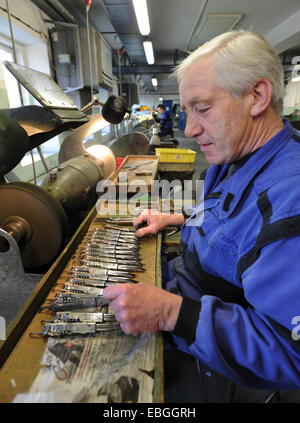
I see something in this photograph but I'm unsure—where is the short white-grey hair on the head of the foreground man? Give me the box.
[174,30,285,114]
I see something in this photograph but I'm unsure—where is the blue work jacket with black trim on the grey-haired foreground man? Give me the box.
[165,121,300,390]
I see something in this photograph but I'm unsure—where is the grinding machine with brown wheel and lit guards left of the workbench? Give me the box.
[0,62,149,321]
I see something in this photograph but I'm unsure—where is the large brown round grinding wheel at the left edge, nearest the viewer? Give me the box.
[0,182,68,268]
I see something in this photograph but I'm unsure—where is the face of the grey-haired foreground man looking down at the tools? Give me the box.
[179,57,252,164]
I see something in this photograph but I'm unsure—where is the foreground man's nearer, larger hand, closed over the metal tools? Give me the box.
[103,282,182,335]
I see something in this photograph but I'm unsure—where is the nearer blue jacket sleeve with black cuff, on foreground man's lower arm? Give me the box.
[173,236,300,390]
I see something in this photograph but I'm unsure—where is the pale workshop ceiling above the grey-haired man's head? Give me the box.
[32,0,300,94]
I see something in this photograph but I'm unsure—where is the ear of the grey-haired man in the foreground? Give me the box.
[250,78,273,117]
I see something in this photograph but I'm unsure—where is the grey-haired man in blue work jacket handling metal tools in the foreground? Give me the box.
[104,31,300,402]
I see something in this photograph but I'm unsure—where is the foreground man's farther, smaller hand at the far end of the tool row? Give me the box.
[133,210,184,237]
